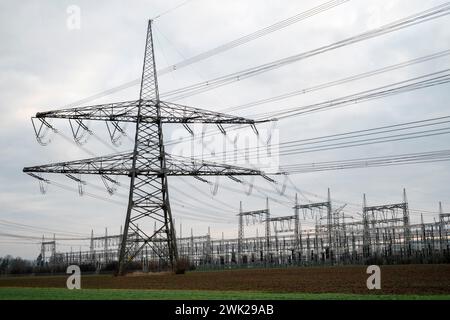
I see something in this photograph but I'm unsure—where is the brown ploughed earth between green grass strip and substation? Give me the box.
[0,265,450,294]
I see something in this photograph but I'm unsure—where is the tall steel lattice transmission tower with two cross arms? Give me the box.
[23,20,271,274]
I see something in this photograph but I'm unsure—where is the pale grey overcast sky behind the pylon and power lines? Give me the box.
[0,0,450,259]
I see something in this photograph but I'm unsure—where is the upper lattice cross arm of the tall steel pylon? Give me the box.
[36,100,267,125]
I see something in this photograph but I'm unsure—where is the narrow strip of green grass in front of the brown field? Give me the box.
[0,288,450,300]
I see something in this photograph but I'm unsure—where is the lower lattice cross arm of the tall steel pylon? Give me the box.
[23,152,269,179]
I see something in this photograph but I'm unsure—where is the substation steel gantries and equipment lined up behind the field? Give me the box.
[38,191,450,271]
